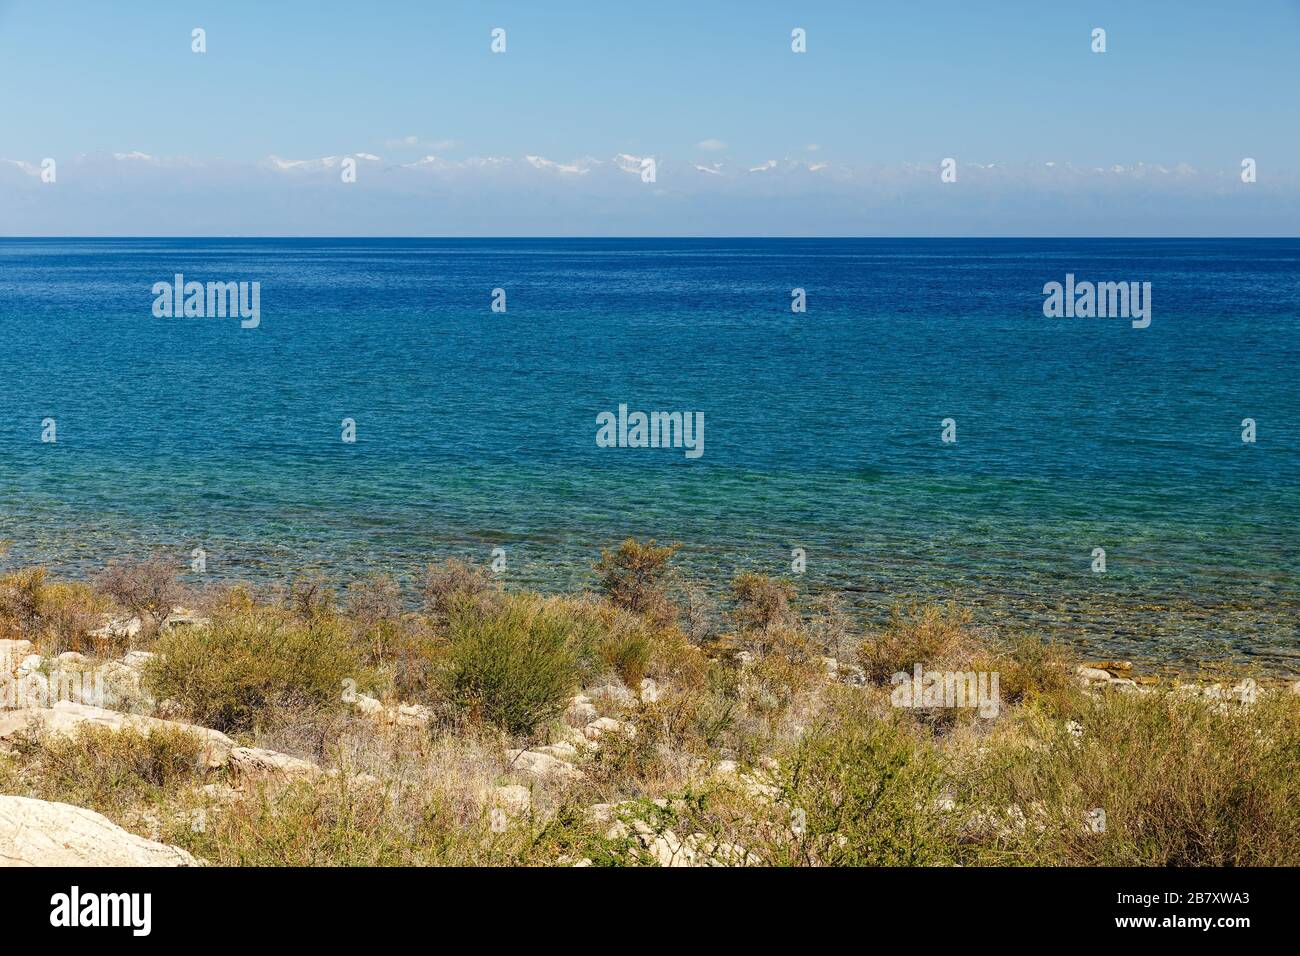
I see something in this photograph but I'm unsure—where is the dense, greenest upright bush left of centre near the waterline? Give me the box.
[446,597,597,734]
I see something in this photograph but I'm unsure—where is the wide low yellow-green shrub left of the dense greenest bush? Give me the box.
[146,609,364,731]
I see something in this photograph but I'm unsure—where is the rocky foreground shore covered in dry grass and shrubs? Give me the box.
[0,538,1300,866]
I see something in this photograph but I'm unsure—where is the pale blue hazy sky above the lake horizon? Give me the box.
[0,0,1300,234]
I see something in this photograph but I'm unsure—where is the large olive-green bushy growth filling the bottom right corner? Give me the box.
[961,691,1300,866]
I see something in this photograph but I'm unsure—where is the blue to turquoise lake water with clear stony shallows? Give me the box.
[0,239,1300,670]
